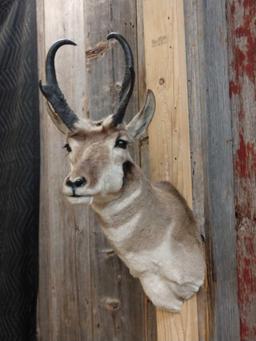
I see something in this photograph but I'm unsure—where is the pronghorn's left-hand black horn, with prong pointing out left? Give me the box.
[39,39,78,130]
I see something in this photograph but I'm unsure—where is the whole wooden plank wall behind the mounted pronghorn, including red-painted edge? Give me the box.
[38,0,256,341]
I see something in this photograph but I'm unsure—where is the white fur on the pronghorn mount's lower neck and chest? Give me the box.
[100,213,203,312]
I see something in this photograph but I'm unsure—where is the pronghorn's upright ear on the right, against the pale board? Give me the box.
[126,90,156,139]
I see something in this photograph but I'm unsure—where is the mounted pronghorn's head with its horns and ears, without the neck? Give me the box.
[40,33,155,204]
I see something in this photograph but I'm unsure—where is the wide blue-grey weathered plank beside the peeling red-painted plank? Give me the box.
[203,0,240,341]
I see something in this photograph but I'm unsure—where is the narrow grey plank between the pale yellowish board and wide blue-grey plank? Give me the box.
[184,0,213,341]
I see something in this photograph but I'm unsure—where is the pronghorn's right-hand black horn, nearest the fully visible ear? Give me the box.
[107,32,135,125]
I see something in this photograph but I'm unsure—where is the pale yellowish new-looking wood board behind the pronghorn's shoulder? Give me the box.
[144,0,199,341]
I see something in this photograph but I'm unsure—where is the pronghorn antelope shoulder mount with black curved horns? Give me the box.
[40,33,205,312]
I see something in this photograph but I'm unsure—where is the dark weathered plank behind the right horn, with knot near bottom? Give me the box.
[85,0,155,341]
